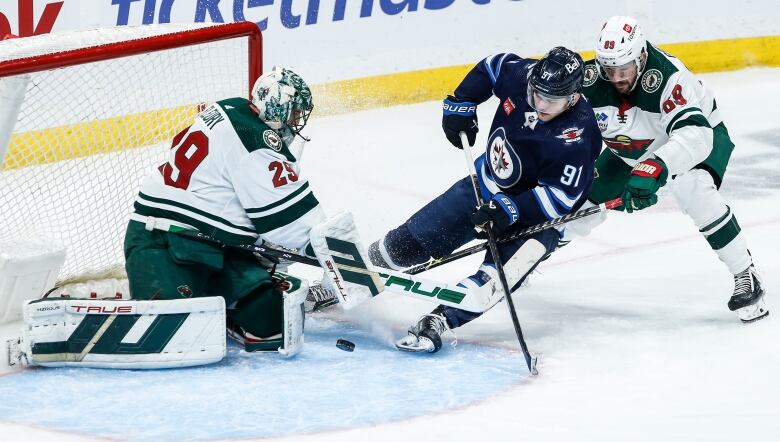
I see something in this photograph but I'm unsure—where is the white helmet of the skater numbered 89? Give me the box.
[596,16,647,89]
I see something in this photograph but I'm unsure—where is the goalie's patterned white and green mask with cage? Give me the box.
[252,67,314,134]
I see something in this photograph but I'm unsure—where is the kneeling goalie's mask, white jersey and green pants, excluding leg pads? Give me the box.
[125,69,325,350]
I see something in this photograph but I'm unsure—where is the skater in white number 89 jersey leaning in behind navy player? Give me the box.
[568,16,769,322]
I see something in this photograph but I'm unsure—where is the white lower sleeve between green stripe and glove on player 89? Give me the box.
[655,126,713,176]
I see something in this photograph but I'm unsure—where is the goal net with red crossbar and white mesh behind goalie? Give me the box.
[0,22,262,280]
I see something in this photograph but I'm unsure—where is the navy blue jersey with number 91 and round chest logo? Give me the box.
[455,54,601,225]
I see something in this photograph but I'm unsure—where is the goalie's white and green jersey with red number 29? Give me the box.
[132,98,325,254]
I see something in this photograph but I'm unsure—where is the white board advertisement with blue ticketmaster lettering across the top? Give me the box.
[0,0,780,83]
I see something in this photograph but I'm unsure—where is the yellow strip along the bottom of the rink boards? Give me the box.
[2,36,780,170]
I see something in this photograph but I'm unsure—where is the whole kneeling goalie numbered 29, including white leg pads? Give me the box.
[9,68,335,368]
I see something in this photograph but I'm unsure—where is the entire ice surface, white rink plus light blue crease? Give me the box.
[0,69,780,442]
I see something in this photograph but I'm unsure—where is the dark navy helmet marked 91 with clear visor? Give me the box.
[528,46,584,110]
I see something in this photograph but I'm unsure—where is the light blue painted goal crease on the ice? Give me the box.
[0,317,527,441]
